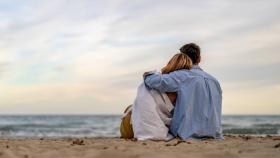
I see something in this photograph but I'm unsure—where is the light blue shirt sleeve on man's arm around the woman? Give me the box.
[144,72,180,92]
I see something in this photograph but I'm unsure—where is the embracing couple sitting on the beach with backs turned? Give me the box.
[120,43,223,140]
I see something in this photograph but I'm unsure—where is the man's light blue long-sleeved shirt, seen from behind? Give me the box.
[145,65,223,140]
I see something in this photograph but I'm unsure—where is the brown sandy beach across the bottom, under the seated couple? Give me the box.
[0,136,280,158]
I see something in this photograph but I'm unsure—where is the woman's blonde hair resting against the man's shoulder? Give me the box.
[161,53,193,74]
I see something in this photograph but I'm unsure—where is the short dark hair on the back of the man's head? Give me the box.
[180,43,200,64]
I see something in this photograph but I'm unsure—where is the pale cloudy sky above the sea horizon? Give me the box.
[0,0,280,114]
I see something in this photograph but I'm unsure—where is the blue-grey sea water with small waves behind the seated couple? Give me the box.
[0,115,280,138]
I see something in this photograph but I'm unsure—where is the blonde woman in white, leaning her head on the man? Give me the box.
[120,53,192,140]
